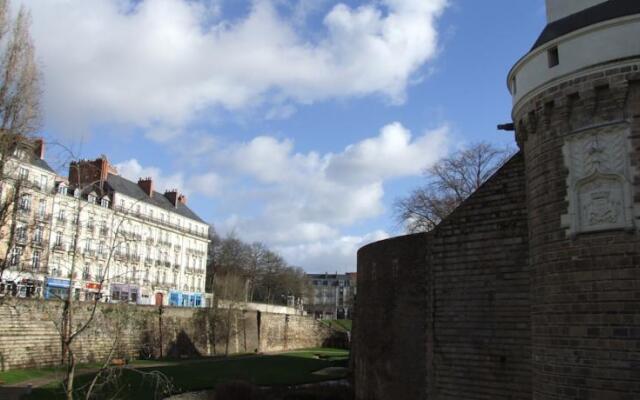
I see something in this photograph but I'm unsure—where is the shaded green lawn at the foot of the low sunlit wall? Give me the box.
[22,349,349,400]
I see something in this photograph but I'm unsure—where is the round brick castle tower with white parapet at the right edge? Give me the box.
[508,0,640,399]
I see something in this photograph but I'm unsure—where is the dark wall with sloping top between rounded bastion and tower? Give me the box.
[426,154,531,400]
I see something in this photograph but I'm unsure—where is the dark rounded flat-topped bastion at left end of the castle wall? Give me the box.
[351,234,427,400]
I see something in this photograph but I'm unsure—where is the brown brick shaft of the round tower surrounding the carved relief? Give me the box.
[514,65,640,400]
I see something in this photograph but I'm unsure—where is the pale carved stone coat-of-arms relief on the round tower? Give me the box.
[563,122,634,236]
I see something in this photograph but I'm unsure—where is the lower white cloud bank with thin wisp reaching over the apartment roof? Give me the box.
[110,122,449,272]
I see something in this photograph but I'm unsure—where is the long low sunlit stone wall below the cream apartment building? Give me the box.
[0,300,343,371]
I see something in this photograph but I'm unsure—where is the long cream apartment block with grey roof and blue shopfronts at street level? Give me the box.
[3,138,209,307]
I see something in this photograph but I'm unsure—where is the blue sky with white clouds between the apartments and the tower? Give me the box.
[22,0,545,273]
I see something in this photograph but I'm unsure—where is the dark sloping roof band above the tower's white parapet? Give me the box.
[531,0,640,50]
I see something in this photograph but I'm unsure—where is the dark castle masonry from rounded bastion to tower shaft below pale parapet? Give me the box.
[353,61,640,400]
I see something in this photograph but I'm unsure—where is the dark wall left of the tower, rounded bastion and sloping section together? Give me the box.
[352,154,531,400]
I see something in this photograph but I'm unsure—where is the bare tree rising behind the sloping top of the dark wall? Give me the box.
[394,142,514,232]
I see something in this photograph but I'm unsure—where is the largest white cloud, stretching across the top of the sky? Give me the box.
[23,0,446,131]
